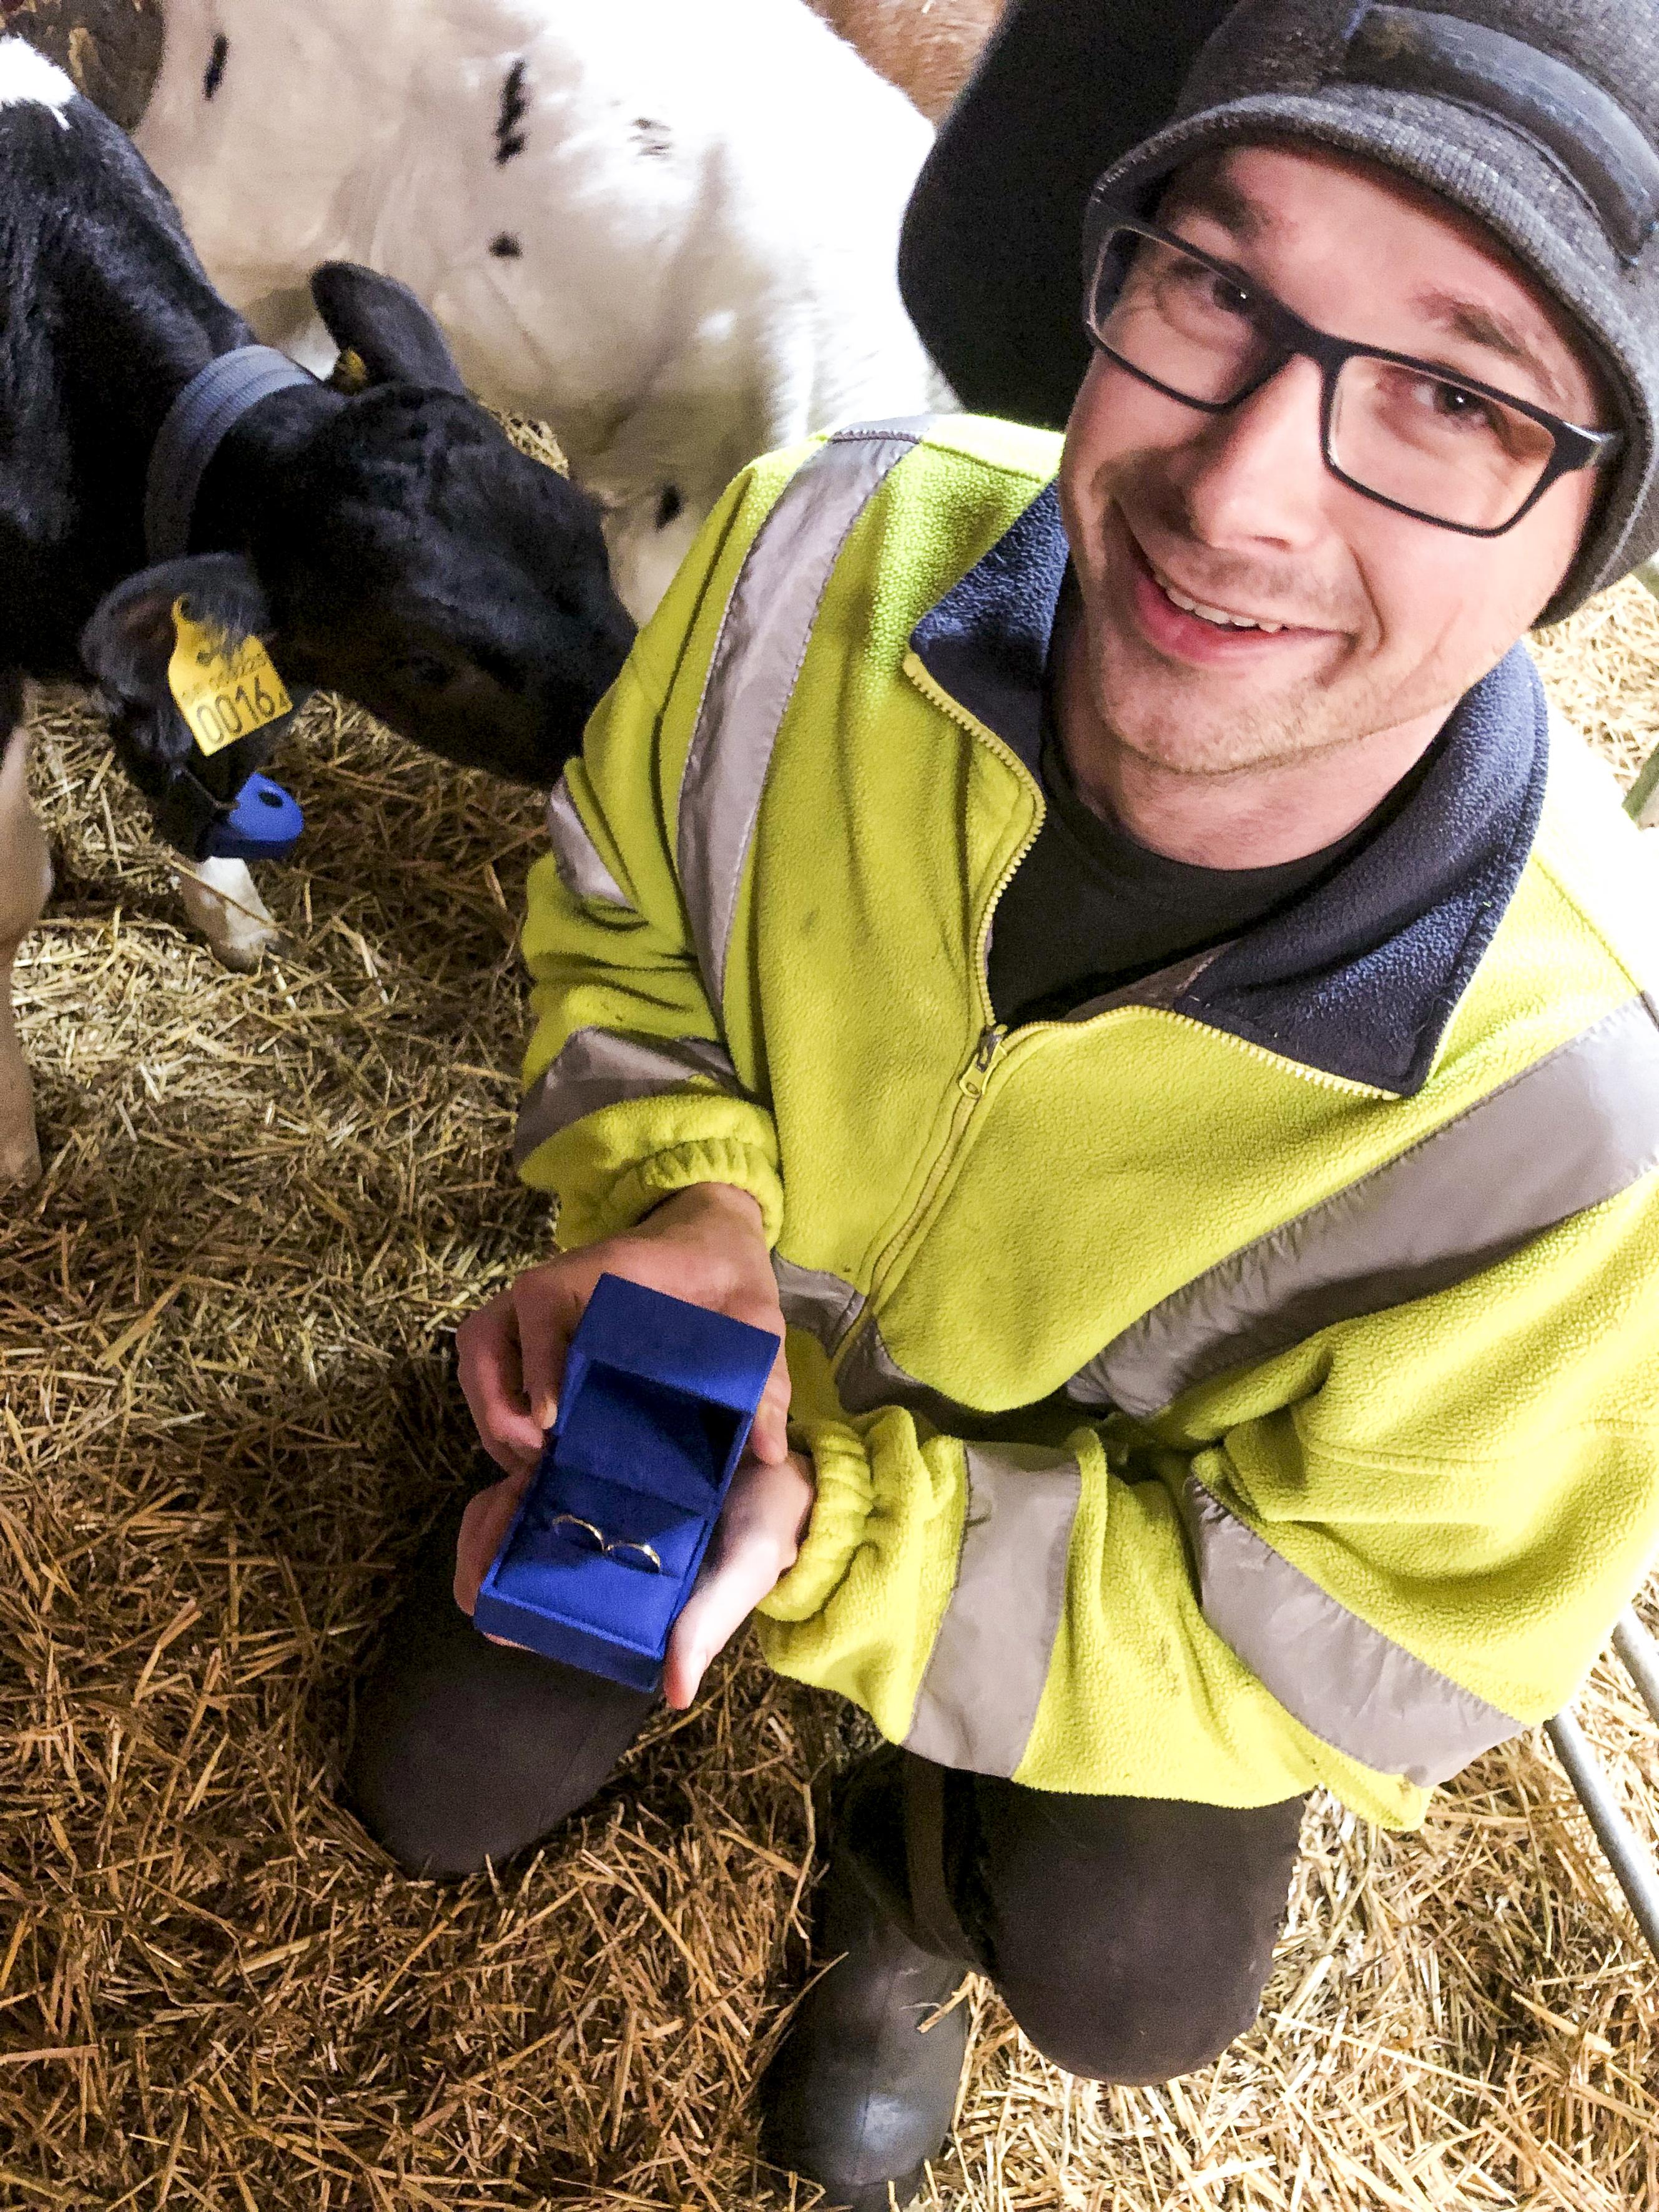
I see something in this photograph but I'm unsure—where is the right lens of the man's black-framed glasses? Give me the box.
[1329,354,1555,531]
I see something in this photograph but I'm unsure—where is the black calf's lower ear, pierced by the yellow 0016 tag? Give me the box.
[80,553,270,799]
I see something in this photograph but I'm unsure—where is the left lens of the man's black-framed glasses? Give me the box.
[1088,230,1269,407]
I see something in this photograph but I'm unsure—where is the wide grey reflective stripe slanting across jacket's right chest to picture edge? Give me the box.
[1066,998,1659,1413]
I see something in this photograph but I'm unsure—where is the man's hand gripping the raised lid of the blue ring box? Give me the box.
[456,1184,790,1477]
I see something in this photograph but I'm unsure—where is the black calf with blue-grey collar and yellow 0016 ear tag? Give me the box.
[0,37,633,1174]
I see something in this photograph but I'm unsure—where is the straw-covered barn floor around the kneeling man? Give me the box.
[0,586,1659,2212]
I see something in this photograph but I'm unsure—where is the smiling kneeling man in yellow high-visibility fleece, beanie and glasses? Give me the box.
[352,0,1659,2212]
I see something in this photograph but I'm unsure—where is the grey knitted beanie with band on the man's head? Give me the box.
[1086,0,1659,622]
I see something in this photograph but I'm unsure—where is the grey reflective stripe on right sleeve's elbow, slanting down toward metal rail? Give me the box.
[1186,1478,1522,1789]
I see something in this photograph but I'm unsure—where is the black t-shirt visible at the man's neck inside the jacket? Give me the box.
[989,714,1435,1028]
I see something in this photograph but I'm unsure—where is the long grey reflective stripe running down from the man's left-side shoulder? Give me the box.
[677,418,929,1011]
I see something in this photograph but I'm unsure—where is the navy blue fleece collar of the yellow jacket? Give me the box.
[912,484,1548,1095]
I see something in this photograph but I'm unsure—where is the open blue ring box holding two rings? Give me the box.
[473,1274,779,1690]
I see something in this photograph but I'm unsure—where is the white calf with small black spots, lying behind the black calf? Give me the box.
[137,0,949,619]
